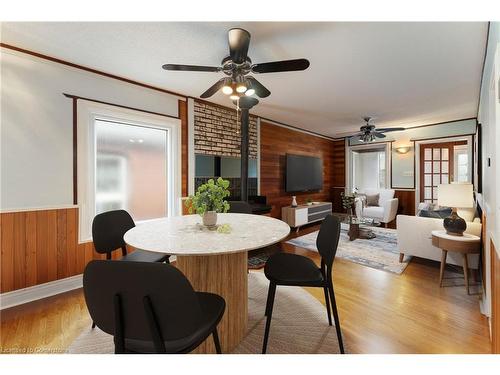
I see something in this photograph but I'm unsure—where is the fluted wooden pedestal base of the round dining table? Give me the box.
[177,252,248,353]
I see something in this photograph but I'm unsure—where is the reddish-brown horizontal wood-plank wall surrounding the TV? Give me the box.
[260,121,345,218]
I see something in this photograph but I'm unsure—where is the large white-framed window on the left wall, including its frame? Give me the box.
[77,99,182,242]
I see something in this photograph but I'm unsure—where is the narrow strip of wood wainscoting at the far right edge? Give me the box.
[490,241,500,354]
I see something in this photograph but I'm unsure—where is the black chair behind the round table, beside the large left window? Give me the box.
[92,210,169,262]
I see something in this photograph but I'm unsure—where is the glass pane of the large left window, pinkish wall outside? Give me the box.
[94,119,168,220]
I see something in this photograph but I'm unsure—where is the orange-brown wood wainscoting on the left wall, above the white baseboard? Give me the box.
[0,208,129,293]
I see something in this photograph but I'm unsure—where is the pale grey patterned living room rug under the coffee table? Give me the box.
[287,223,411,275]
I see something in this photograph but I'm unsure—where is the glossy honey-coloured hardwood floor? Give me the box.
[0,225,491,353]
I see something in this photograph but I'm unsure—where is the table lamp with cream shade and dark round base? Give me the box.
[438,183,474,236]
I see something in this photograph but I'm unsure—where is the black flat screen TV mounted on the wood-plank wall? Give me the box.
[285,154,323,193]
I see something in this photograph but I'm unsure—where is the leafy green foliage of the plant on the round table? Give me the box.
[185,177,230,216]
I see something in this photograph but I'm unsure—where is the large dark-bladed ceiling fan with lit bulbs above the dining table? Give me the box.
[163,28,309,101]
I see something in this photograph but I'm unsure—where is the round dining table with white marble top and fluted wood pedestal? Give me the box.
[123,214,290,353]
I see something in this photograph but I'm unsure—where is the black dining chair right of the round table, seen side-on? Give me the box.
[262,215,344,354]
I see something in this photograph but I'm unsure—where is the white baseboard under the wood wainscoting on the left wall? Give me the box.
[0,275,83,310]
